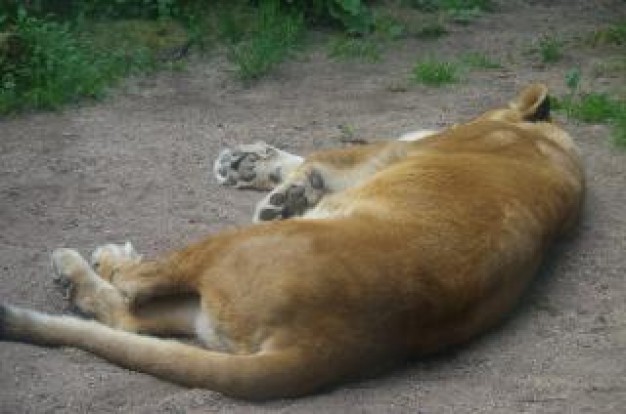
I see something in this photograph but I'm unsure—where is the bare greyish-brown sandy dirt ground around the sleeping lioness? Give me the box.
[0,0,626,414]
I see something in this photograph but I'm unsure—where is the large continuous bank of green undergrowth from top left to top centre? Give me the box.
[0,0,382,113]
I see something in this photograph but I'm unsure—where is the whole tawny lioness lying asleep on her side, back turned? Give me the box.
[0,84,584,399]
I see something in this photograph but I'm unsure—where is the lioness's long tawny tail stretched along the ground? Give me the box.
[0,305,327,399]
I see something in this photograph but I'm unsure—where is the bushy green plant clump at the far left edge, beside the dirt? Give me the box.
[0,11,152,113]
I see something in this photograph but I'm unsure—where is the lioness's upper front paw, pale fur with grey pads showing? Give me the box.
[213,142,302,190]
